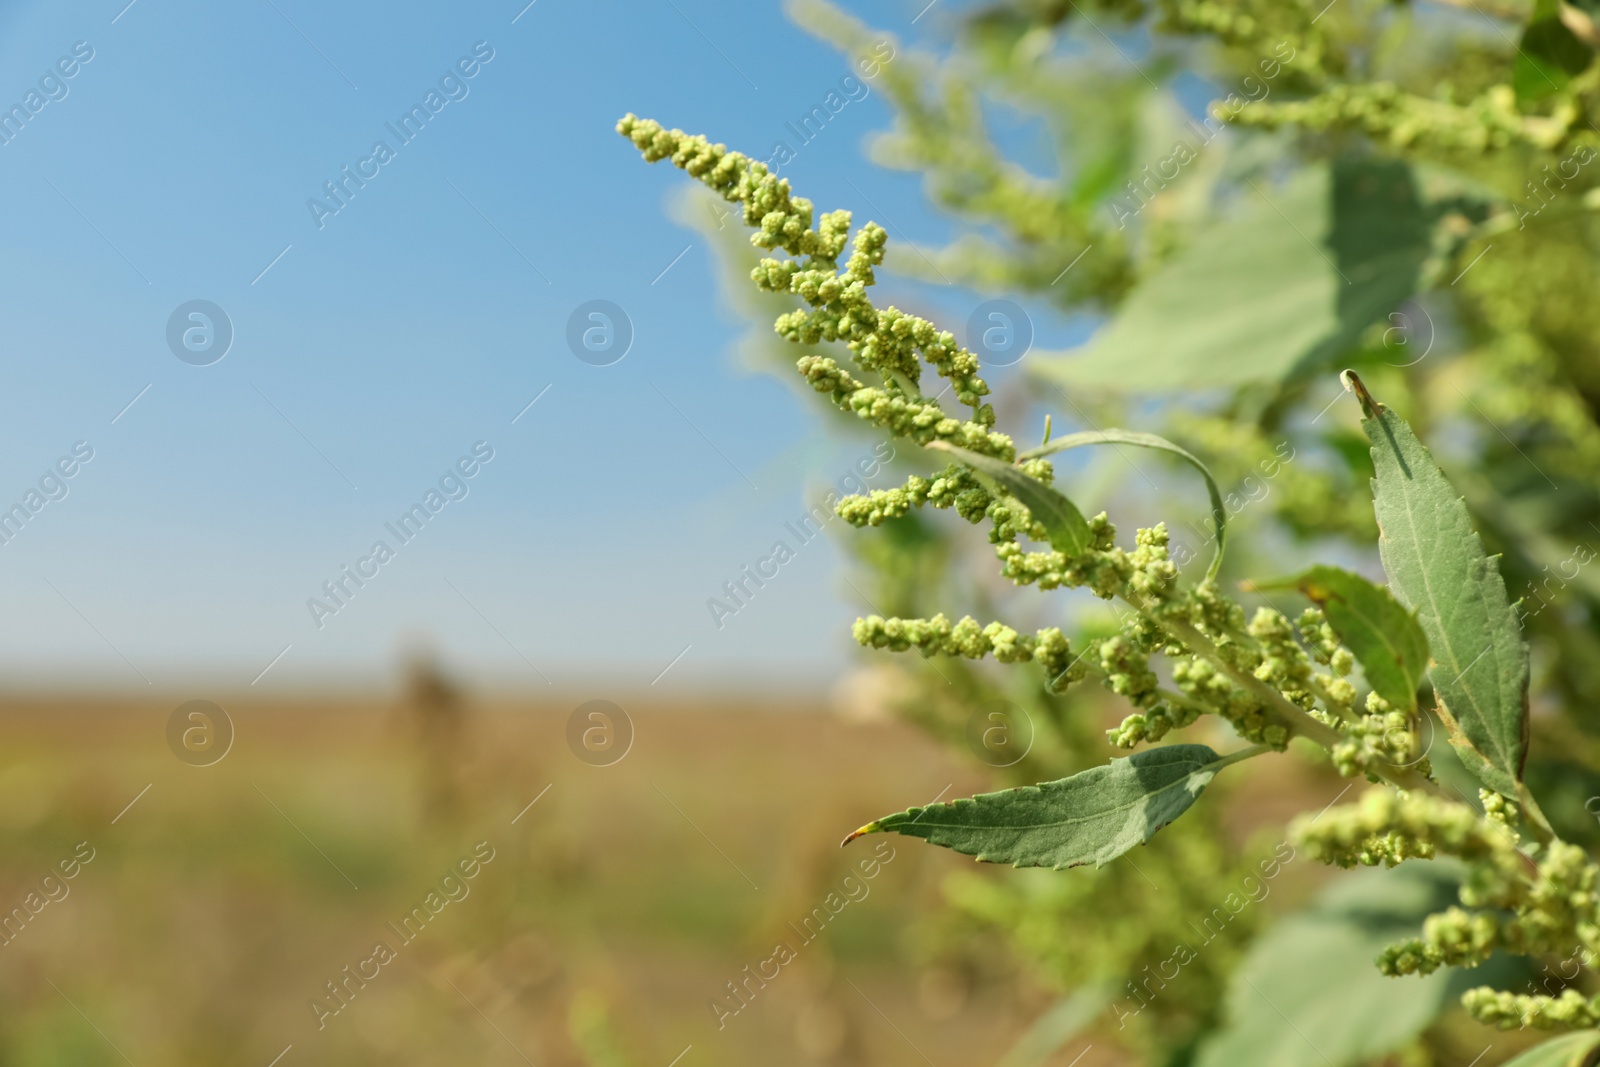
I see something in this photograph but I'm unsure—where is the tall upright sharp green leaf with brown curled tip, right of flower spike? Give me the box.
[1346,371,1528,797]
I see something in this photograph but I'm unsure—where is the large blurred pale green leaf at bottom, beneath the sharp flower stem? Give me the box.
[1189,864,1483,1067]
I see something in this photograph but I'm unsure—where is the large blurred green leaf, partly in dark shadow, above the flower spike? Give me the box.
[1034,158,1430,392]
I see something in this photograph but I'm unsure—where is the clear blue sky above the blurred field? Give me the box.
[0,0,1094,691]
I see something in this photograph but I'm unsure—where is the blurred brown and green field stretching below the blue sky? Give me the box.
[0,684,1075,1067]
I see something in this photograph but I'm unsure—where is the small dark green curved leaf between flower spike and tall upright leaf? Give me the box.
[1253,566,1427,712]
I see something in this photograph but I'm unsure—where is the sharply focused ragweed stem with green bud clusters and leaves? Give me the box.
[618,112,1600,1064]
